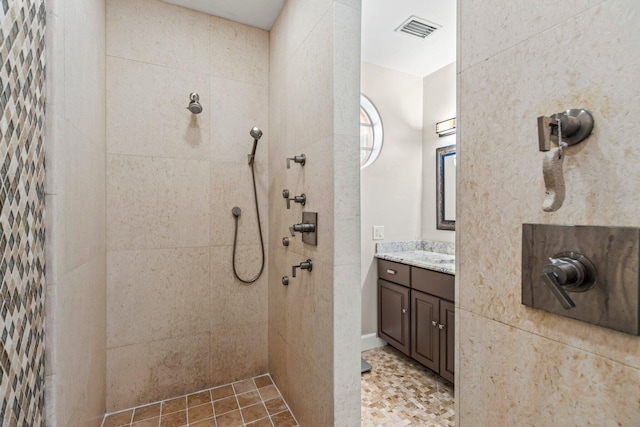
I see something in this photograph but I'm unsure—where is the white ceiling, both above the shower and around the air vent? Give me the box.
[164,0,456,77]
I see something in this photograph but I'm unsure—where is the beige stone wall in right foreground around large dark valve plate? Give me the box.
[456,0,640,426]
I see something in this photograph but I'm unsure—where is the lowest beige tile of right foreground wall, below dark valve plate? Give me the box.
[456,310,640,425]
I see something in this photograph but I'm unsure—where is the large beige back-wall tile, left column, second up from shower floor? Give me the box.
[107,247,211,348]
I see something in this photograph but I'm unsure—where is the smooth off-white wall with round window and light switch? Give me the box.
[360,63,424,335]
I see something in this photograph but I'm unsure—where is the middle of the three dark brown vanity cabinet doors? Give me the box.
[411,290,440,372]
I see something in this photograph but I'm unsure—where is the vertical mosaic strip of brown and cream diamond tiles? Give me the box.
[0,0,45,426]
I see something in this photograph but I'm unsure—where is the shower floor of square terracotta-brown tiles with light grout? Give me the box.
[102,375,298,427]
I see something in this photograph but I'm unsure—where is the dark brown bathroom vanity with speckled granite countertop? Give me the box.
[376,242,455,382]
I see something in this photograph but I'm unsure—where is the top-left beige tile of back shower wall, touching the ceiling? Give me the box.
[107,0,211,72]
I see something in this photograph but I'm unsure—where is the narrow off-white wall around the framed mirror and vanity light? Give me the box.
[422,62,456,242]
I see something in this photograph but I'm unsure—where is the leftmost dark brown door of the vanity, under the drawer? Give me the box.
[378,279,410,355]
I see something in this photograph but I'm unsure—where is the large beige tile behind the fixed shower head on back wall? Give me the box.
[107,56,212,160]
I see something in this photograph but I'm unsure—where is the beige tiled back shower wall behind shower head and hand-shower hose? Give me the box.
[106,0,271,411]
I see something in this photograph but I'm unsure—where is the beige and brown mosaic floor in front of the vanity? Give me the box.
[361,345,455,427]
